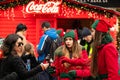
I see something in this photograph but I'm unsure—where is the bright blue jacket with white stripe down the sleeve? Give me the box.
[37,28,58,62]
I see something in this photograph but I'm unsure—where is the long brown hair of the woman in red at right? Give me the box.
[91,31,103,77]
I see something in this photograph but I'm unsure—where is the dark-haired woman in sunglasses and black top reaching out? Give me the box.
[0,34,49,80]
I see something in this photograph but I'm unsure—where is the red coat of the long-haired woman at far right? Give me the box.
[98,43,120,80]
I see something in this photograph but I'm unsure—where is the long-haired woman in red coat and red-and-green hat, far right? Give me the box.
[91,20,120,80]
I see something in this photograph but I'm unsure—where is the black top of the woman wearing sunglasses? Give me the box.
[0,55,42,80]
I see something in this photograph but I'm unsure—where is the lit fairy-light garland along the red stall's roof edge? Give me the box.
[0,0,118,18]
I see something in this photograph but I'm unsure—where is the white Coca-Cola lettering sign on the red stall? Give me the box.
[26,1,61,13]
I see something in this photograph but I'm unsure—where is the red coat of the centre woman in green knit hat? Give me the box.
[52,46,90,80]
